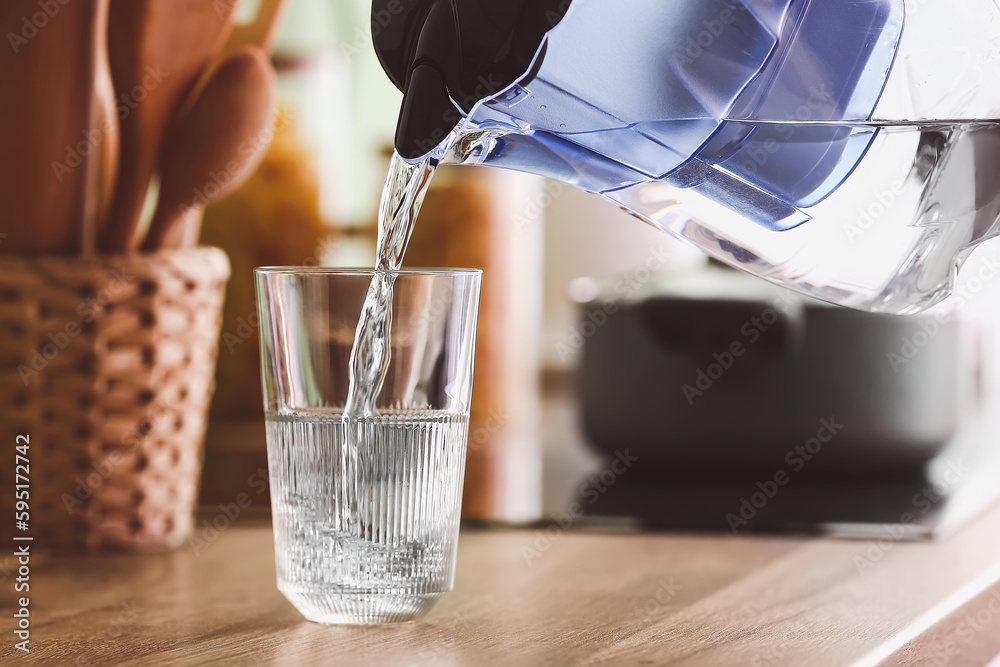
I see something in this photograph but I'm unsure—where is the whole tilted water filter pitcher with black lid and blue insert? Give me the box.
[373,0,1000,313]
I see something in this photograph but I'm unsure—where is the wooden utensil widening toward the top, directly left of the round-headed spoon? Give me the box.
[101,0,236,252]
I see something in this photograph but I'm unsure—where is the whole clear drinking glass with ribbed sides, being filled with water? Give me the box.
[256,268,482,624]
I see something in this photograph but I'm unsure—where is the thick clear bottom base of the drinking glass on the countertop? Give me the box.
[279,587,447,625]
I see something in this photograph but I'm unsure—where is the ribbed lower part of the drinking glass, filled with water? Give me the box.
[267,411,469,623]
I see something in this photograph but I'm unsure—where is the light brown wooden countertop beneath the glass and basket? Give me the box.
[0,508,1000,667]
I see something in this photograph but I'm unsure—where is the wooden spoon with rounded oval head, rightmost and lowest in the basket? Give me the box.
[143,47,277,251]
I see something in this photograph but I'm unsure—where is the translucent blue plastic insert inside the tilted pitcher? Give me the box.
[470,0,904,230]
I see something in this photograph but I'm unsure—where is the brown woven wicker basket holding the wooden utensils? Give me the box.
[0,248,229,550]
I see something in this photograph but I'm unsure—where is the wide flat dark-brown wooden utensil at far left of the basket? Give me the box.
[0,0,108,255]
